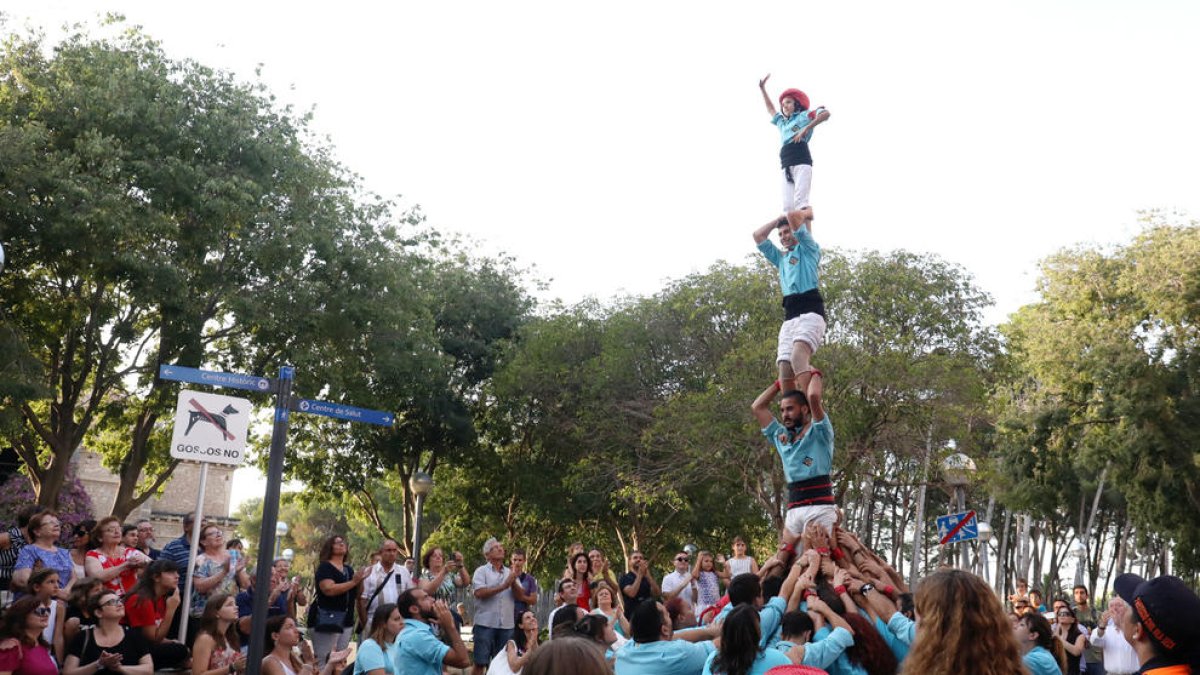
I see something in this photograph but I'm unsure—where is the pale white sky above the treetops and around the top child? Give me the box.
[0,0,1200,511]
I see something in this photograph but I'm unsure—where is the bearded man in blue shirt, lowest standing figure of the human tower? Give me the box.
[750,370,838,555]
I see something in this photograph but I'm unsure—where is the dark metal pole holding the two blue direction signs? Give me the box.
[246,365,295,675]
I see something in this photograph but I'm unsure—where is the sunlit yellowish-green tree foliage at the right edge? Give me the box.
[997,214,1200,571]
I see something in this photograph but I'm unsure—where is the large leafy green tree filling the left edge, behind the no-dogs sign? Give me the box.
[0,23,415,516]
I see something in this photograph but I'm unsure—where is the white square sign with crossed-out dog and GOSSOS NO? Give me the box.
[170,389,253,465]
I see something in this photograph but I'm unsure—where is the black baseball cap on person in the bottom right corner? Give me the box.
[1114,574,1200,656]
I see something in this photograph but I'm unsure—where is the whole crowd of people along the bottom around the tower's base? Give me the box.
[0,499,1200,675]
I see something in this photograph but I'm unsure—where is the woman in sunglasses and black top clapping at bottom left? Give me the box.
[62,591,154,675]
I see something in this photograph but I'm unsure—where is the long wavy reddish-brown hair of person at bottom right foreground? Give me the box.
[902,569,1026,675]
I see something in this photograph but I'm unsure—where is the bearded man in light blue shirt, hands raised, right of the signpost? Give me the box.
[395,589,470,675]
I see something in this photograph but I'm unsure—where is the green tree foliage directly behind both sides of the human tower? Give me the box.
[431,252,996,573]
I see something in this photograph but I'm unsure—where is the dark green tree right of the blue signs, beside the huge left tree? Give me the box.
[276,252,533,552]
